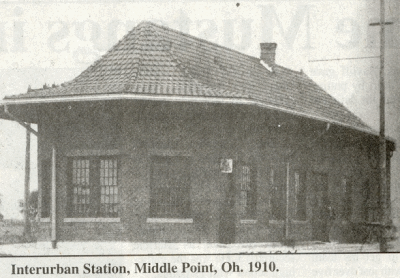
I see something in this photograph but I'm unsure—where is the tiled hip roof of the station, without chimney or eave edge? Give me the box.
[6,22,372,132]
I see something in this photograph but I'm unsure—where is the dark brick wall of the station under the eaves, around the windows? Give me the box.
[38,102,377,242]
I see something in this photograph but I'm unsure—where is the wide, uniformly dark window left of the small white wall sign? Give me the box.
[150,156,190,218]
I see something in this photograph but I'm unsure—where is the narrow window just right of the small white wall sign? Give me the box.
[240,166,256,219]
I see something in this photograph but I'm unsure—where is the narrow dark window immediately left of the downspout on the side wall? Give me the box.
[270,168,286,220]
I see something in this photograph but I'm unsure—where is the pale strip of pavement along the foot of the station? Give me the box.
[0,241,379,256]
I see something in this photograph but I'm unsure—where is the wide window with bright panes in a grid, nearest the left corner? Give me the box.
[68,157,118,217]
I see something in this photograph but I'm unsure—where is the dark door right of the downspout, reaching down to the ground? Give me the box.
[310,173,329,242]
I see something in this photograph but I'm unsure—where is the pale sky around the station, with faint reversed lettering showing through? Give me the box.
[0,0,400,222]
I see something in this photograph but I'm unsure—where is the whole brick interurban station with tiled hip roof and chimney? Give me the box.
[0,22,395,243]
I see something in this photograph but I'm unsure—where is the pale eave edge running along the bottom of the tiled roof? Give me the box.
[0,93,395,146]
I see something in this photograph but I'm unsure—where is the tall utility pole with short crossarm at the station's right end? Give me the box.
[370,0,393,253]
